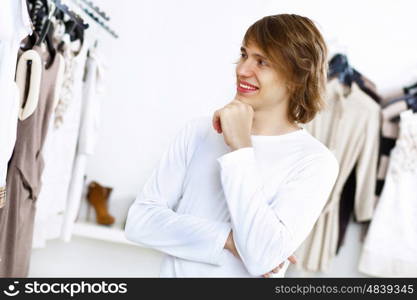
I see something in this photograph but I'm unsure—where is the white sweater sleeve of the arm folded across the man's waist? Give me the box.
[125,121,231,265]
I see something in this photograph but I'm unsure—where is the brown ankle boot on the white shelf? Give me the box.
[87,181,115,225]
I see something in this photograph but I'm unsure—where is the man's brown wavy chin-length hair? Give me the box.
[243,14,327,123]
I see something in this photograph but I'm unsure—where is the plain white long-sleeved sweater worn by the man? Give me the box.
[125,117,338,277]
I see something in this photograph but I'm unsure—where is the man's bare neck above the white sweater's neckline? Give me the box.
[251,106,300,135]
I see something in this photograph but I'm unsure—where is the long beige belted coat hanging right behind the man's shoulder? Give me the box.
[295,79,380,272]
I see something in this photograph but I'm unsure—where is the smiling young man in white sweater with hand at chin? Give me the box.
[126,15,338,277]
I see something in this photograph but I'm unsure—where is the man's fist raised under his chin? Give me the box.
[213,99,254,151]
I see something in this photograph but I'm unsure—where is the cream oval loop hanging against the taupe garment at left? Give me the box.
[16,50,43,121]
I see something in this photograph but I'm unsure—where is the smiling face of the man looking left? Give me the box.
[236,43,288,111]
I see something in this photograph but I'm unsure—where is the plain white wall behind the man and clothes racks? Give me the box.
[31,0,417,276]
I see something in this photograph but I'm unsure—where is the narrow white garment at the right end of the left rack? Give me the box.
[61,49,102,242]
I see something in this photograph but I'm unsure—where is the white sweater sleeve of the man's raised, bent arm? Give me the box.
[218,147,338,276]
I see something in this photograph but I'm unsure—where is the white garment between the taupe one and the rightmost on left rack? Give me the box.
[33,40,88,248]
